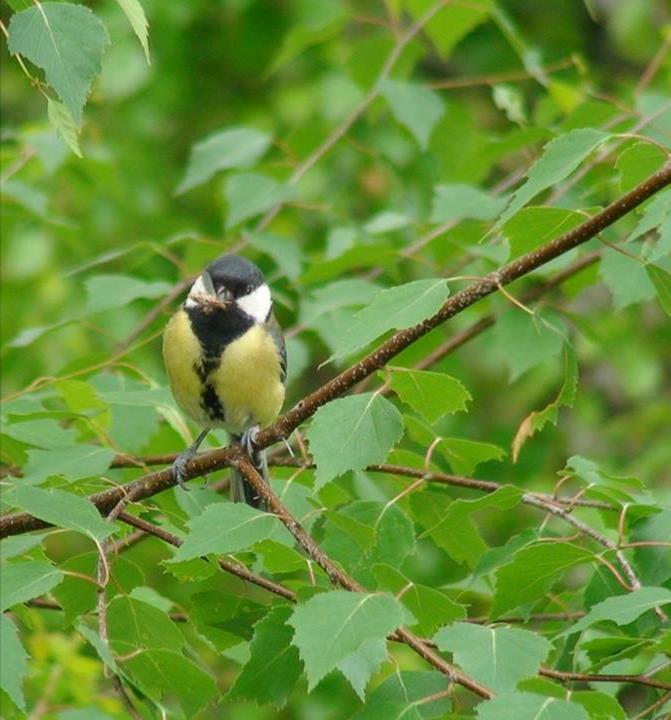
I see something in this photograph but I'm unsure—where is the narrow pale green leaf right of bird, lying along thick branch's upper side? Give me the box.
[329,278,450,360]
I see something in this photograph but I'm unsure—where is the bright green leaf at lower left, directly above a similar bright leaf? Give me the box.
[107,595,184,655]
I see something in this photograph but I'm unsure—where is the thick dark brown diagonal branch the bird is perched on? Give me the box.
[0,162,671,537]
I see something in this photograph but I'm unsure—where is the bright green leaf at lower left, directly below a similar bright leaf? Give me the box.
[123,650,219,717]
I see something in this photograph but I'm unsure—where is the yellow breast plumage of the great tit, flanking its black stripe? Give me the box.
[163,309,284,435]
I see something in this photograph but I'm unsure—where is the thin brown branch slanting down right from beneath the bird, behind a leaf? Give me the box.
[235,452,494,698]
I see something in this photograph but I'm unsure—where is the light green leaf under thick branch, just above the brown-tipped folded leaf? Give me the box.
[493,308,565,382]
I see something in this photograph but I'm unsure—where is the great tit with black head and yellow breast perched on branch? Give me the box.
[163,255,287,507]
